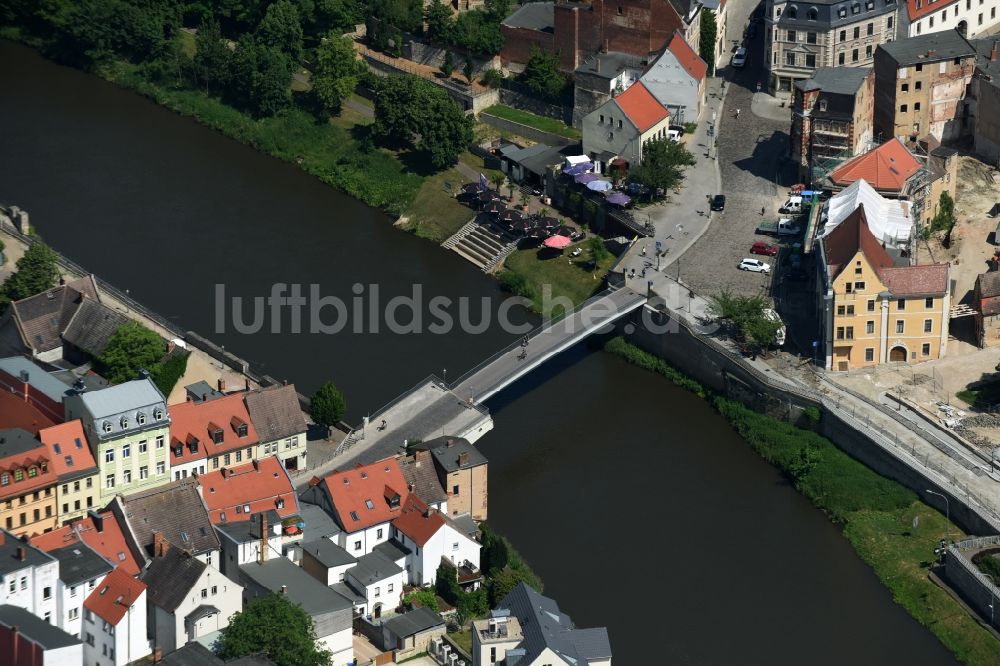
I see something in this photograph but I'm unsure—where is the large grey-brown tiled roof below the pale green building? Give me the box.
[118,477,219,556]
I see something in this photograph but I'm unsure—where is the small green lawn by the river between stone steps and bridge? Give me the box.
[501,241,616,315]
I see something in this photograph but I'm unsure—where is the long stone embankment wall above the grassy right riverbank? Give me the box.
[618,301,1000,535]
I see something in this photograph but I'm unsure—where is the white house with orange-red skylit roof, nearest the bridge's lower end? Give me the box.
[299,458,410,557]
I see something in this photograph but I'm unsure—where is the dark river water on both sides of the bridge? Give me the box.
[0,42,954,665]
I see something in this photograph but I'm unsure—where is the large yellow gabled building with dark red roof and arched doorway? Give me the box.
[816,205,951,371]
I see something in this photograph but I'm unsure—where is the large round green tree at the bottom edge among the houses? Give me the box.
[219,594,332,666]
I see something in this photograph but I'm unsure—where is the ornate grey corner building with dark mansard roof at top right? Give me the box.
[764,0,899,97]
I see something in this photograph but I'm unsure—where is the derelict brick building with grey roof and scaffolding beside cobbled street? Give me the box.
[789,67,875,182]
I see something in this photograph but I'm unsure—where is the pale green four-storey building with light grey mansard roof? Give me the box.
[65,377,170,506]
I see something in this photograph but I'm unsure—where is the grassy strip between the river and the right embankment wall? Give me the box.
[604,337,1000,665]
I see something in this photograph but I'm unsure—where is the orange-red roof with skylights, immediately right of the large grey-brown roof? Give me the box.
[198,456,299,533]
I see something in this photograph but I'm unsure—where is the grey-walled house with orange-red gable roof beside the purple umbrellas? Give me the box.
[582,82,670,172]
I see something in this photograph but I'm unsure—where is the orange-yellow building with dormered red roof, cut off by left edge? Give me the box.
[0,428,58,535]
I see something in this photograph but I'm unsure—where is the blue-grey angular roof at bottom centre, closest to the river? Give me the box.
[499,583,611,663]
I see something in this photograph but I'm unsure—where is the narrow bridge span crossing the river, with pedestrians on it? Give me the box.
[452,287,646,404]
